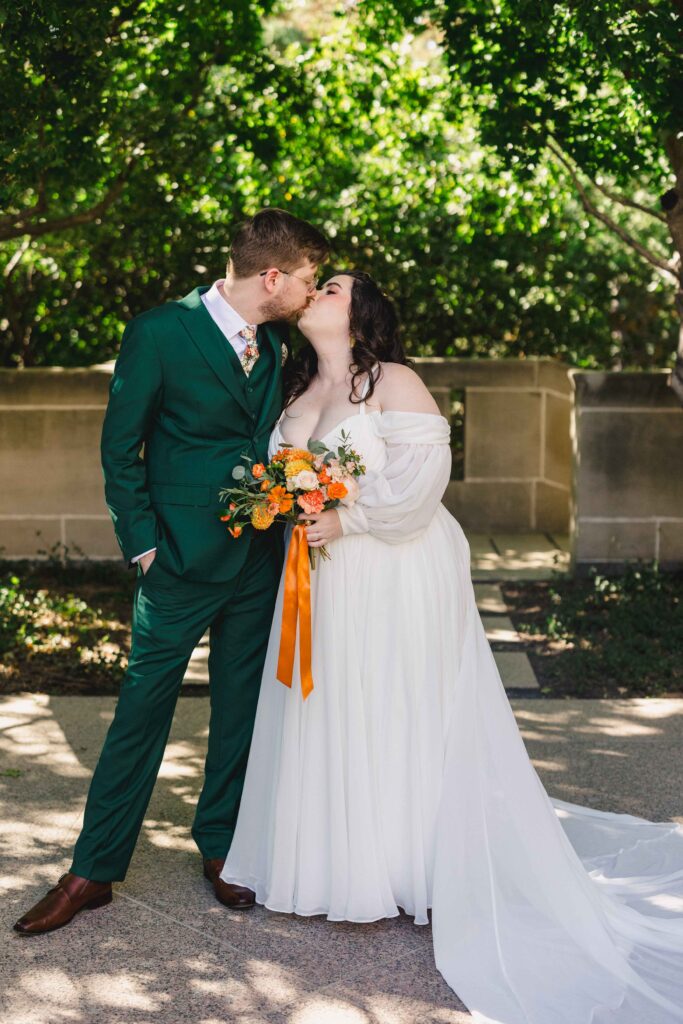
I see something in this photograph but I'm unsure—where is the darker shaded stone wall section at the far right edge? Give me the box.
[570,371,683,567]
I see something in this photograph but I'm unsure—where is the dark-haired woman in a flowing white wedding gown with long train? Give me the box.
[221,271,683,1024]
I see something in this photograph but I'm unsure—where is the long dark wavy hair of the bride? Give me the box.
[285,270,408,408]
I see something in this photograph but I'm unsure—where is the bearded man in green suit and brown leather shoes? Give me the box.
[14,209,328,935]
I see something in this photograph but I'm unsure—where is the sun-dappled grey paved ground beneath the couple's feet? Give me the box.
[0,696,683,1024]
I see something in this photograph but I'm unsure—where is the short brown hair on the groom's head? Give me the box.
[228,207,330,278]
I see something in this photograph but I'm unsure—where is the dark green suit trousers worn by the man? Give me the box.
[71,531,282,882]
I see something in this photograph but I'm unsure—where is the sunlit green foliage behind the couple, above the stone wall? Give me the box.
[0,0,674,367]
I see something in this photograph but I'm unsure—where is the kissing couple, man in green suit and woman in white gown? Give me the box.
[14,209,683,1024]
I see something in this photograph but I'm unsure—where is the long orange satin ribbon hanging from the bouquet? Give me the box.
[278,526,313,700]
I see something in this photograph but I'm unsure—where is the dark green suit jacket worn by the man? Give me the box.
[101,288,289,582]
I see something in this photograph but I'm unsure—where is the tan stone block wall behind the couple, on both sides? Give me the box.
[0,358,683,566]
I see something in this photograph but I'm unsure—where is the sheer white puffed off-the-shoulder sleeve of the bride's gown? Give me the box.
[337,413,451,544]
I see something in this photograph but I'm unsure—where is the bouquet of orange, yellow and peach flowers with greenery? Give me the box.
[219,431,366,568]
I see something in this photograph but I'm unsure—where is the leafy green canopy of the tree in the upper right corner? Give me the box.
[379,0,683,387]
